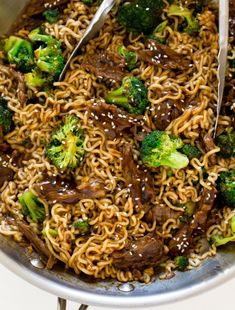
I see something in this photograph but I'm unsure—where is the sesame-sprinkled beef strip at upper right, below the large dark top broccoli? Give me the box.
[138,39,188,70]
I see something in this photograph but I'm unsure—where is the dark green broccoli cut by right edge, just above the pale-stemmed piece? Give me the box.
[218,170,235,208]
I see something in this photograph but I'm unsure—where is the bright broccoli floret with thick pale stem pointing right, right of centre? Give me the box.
[140,130,189,169]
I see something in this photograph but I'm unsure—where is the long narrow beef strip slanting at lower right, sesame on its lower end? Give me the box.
[169,187,217,256]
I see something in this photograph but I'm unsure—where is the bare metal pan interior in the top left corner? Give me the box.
[0,0,29,35]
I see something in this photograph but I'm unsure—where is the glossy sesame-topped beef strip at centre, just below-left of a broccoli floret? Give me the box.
[88,102,143,139]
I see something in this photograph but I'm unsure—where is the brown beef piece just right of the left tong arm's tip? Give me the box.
[81,51,129,82]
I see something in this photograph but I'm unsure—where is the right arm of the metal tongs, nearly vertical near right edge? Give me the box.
[214,0,229,135]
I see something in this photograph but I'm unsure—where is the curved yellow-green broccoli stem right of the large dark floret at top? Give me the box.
[167,4,200,35]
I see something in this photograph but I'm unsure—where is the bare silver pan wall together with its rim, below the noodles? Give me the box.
[0,236,235,308]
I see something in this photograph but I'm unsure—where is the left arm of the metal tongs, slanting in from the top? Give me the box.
[59,0,116,81]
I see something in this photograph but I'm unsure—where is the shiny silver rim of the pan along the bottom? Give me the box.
[0,250,235,308]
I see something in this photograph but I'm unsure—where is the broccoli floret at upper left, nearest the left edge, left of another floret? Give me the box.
[4,36,34,73]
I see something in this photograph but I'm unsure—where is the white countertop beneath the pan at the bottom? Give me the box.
[0,265,235,310]
